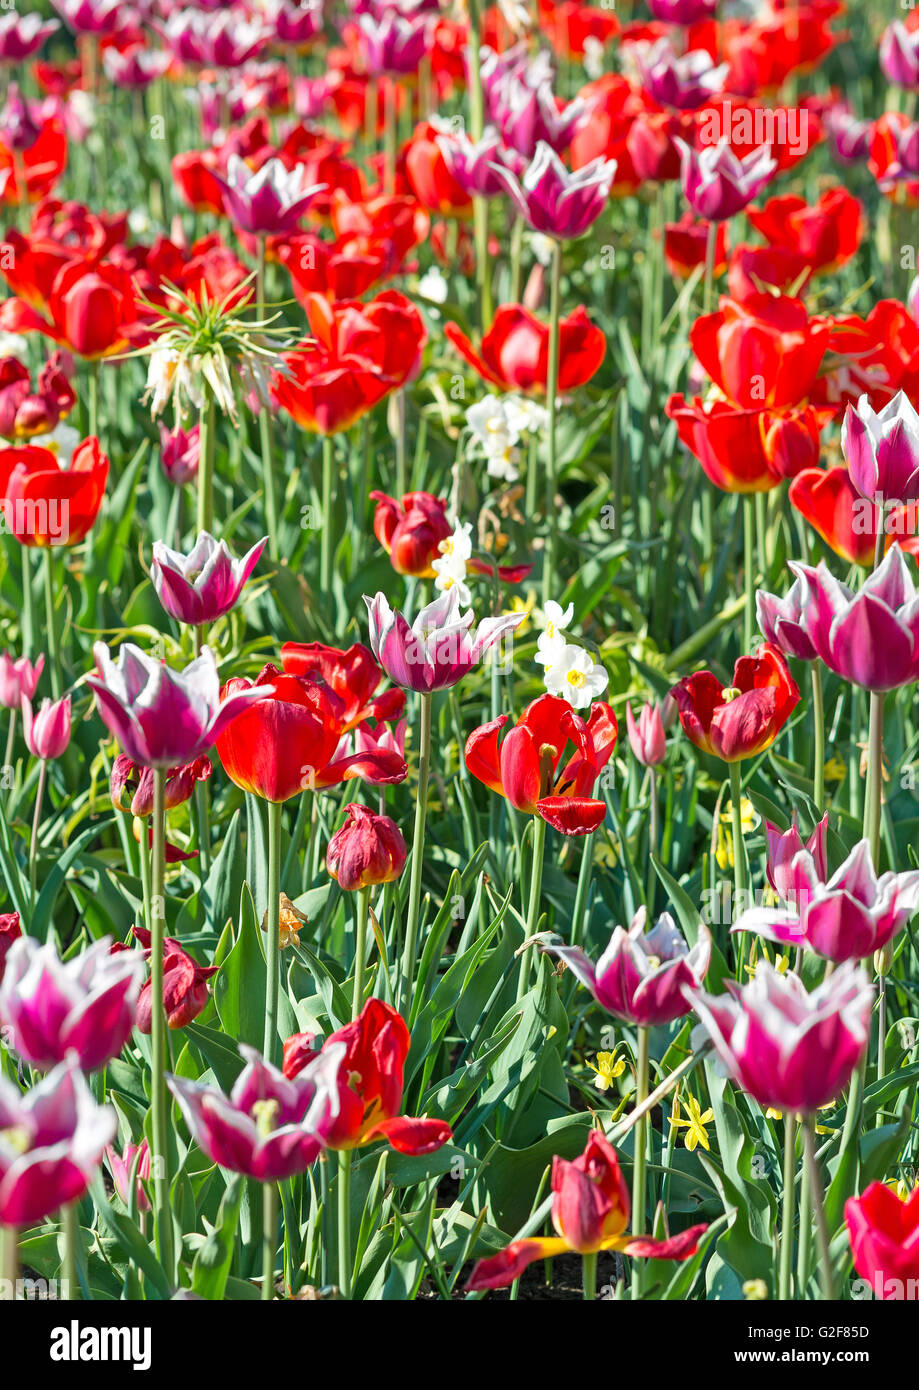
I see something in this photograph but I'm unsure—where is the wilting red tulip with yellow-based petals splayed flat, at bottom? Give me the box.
[466,1130,706,1291]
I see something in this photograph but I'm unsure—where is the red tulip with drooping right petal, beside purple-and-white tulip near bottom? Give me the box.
[284,999,453,1154]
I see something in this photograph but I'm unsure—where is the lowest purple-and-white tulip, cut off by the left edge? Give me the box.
[0,1059,118,1227]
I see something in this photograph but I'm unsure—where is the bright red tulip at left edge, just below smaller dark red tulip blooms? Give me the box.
[0,438,108,546]
